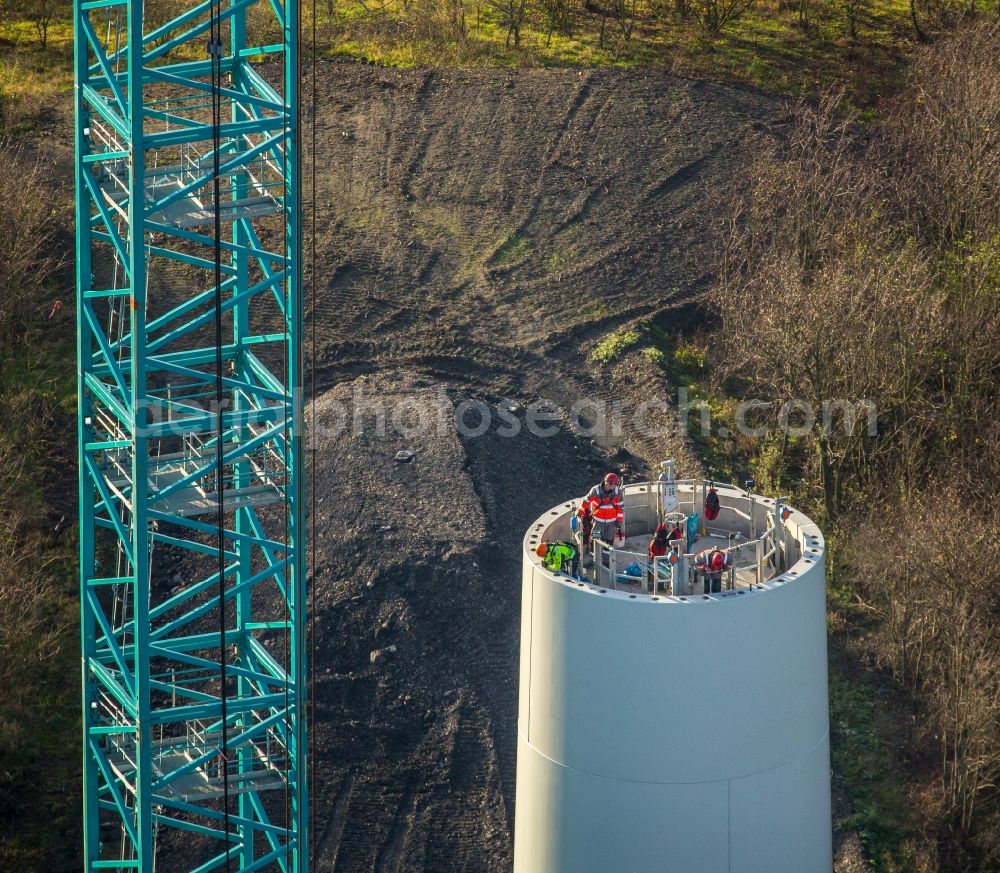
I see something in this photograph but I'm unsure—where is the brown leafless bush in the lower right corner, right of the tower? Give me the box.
[847,484,1000,869]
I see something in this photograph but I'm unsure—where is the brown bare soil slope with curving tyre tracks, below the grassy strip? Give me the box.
[305,65,783,391]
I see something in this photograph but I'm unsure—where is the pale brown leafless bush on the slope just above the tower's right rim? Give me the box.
[715,96,942,516]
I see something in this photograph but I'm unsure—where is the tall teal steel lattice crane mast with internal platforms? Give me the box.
[74,0,308,873]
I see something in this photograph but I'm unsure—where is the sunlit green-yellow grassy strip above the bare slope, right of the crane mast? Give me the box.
[304,0,913,106]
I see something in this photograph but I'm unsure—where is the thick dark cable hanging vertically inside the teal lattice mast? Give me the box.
[208,0,231,873]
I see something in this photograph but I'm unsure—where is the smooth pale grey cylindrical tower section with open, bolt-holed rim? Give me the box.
[514,483,832,873]
